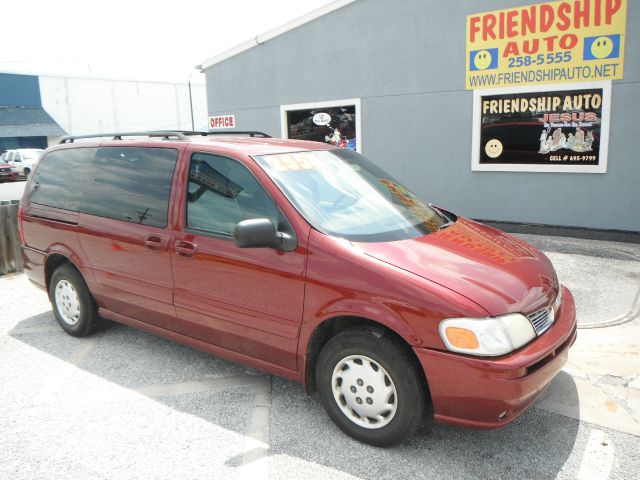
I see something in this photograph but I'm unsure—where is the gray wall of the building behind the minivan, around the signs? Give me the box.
[206,0,640,231]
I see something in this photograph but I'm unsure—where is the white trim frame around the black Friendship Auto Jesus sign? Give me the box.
[471,80,611,173]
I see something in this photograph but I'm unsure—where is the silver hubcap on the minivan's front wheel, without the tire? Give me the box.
[331,355,398,429]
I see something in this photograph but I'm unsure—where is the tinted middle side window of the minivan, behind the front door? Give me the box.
[80,147,178,227]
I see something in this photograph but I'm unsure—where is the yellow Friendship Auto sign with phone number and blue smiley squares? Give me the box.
[465,0,627,90]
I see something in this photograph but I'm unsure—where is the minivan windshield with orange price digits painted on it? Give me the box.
[255,149,450,242]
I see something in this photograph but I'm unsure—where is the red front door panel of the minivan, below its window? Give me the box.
[173,234,305,369]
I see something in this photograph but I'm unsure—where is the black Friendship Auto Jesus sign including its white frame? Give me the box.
[472,82,611,173]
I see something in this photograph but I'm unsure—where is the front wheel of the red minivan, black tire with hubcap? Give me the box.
[316,328,426,447]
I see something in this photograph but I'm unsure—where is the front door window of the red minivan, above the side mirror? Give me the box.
[187,153,288,235]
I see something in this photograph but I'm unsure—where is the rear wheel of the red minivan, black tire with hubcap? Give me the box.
[49,263,100,337]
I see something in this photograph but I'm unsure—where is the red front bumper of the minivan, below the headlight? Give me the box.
[414,287,577,428]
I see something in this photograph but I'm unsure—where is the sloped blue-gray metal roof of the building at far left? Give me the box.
[0,106,67,137]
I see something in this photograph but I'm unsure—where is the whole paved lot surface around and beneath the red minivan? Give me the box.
[0,237,640,480]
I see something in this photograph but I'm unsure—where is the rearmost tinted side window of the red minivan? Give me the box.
[29,148,96,211]
